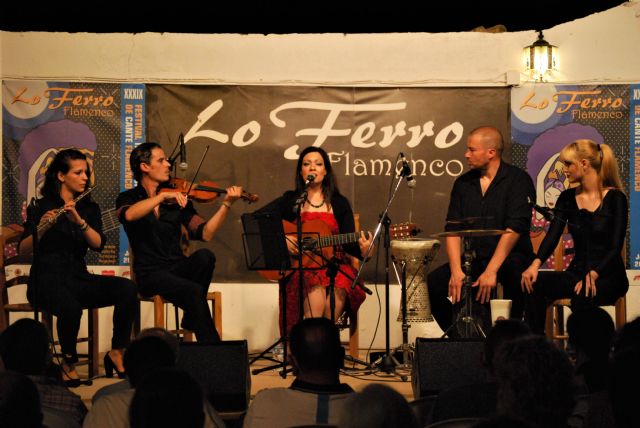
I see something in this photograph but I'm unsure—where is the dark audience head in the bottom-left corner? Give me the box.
[0,372,42,428]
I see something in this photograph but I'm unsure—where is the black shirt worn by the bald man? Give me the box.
[445,161,535,260]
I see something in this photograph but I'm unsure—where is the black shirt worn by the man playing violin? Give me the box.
[116,185,205,276]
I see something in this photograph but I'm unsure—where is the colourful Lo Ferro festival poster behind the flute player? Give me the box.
[2,80,145,274]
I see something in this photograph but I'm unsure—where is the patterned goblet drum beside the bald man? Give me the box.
[391,238,440,322]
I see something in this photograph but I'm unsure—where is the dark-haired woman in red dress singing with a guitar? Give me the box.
[259,146,372,336]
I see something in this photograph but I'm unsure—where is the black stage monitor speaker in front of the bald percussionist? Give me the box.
[411,337,487,399]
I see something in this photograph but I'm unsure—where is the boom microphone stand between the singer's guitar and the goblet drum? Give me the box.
[351,168,407,374]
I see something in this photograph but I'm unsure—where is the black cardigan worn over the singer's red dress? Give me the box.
[257,190,362,259]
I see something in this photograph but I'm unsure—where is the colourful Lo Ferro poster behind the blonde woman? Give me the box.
[511,83,640,269]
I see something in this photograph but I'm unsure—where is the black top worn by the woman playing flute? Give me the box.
[22,197,107,280]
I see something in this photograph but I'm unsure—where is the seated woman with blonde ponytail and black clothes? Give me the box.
[521,140,629,333]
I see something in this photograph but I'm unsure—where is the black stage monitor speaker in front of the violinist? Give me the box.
[177,340,251,412]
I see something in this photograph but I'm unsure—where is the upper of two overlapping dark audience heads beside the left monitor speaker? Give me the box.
[124,336,176,388]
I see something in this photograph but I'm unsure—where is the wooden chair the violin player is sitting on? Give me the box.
[129,226,222,342]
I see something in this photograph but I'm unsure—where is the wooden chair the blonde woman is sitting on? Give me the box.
[536,229,627,348]
